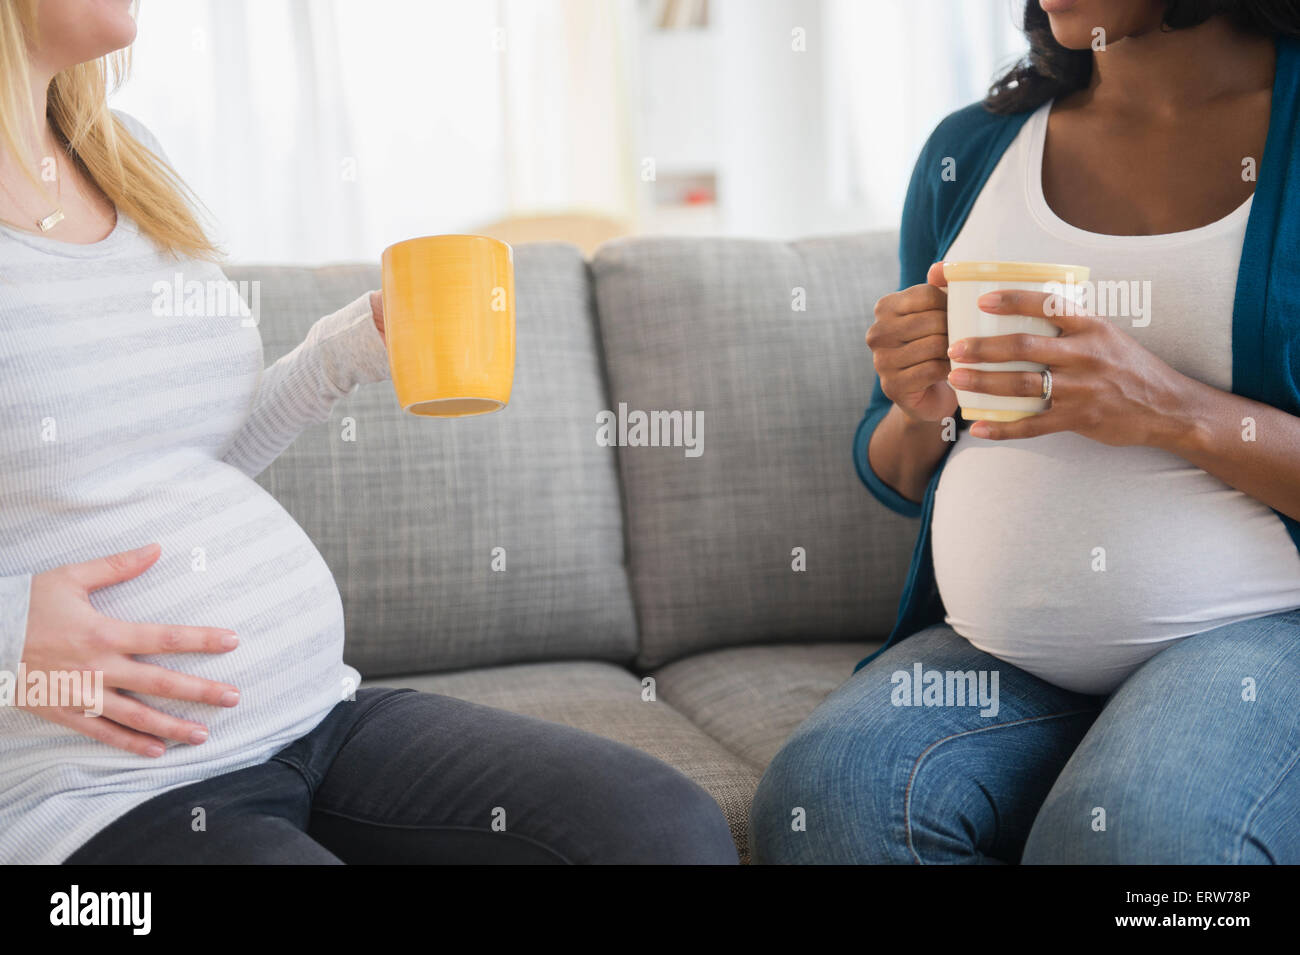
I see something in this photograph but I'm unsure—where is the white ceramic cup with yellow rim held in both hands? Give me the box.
[944,261,1088,421]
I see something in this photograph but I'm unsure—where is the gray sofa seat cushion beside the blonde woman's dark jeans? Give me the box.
[368,663,758,861]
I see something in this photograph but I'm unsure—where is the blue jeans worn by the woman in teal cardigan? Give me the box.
[750,611,1300,864]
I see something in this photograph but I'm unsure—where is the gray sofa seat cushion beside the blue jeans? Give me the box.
[651,643,880,773]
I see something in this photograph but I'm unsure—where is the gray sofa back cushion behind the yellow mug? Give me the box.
[236,244,636,677]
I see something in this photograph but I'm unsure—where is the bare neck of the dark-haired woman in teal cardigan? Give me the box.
[1087,17,1277,114]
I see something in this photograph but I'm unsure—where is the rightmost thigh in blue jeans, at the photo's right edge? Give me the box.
[1024,611,1300,864]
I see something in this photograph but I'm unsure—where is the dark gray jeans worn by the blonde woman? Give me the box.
[68,687,737,865]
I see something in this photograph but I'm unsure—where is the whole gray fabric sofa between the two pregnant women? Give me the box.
[228,234,917,858]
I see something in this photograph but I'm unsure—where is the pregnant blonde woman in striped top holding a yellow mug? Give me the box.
[0,0,736,864]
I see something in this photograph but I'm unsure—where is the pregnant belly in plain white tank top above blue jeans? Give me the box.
[932,433,1300,693]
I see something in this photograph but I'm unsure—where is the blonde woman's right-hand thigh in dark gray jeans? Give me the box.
[308,691,737,864]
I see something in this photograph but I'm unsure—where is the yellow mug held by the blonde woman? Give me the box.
[382,235,515,418]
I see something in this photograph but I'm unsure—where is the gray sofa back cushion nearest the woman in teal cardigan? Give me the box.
[592,234,917,668]
